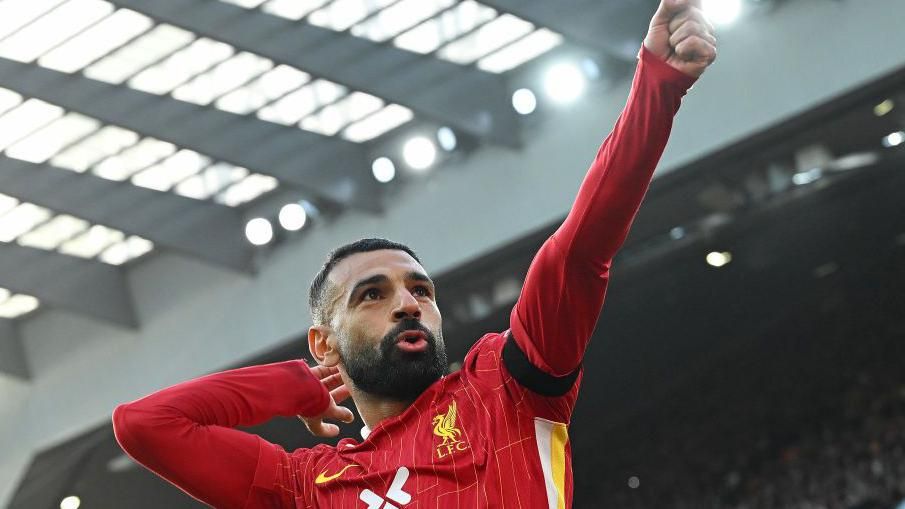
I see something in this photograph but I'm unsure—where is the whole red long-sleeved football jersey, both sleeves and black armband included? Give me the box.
[113,45,694,509]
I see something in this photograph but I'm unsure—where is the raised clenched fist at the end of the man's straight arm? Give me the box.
[644,0,716,78]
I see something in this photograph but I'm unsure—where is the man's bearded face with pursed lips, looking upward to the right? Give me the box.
[312,249,448,401]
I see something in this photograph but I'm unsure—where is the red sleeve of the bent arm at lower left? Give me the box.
[113,360,329,508]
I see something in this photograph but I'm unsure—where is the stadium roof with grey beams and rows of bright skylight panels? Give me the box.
[0,0,654,346]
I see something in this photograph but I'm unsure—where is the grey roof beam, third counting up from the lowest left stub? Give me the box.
[0,156,253,272]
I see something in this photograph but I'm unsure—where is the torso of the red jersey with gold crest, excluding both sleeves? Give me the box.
[268,334,578,509]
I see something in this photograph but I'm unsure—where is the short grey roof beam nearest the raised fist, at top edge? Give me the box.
[481,0,658,62]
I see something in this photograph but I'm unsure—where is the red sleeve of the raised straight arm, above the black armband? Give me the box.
[510,48,695,376]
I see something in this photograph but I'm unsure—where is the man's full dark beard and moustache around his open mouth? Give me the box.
[339,319,449,401]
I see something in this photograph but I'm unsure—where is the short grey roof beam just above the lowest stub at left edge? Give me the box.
[0,242,138,328]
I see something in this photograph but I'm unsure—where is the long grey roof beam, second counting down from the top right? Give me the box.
[106,0,521,146]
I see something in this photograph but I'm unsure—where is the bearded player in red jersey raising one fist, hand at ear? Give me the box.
[113,0,716,509]
